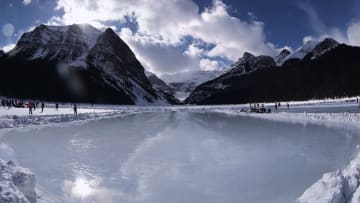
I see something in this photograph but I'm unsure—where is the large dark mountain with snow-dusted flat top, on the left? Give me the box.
[0,24,177,105]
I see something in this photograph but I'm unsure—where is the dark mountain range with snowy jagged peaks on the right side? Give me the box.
[185,39,360,104]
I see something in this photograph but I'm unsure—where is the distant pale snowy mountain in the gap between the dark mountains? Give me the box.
[161,70,224,101]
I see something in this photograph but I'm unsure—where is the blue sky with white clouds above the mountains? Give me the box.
[0,0,360,75]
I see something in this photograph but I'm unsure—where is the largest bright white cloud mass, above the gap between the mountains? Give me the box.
[50,0,276,74]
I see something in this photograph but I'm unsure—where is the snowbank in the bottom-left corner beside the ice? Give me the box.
[0,160,36,203]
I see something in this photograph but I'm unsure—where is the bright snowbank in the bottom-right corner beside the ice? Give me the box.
[297,153,360,203]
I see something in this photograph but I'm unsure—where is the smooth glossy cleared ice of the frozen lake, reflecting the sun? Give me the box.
[0,112,360,203]
